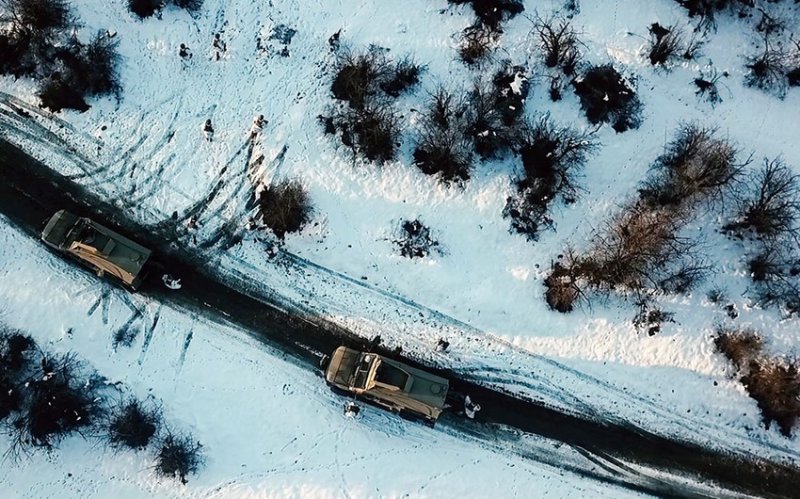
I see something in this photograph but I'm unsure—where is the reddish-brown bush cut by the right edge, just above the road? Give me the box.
[742,359,800,437]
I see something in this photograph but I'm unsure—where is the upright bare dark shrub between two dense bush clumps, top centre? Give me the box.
[414,87,472,182]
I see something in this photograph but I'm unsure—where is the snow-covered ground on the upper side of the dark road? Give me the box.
[0,0,800,492]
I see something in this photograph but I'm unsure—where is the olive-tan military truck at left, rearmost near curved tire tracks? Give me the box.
[42,210,151,290]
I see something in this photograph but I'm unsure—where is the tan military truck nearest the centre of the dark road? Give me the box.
[325,346,449,426]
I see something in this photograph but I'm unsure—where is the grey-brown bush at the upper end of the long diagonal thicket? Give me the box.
[639,124,744,208]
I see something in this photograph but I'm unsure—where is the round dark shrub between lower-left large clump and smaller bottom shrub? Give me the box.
[108,398,161,450]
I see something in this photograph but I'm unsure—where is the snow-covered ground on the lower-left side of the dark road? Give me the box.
[0,217,644,499]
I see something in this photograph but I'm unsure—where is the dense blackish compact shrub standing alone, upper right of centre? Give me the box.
[572,64,641,133]
